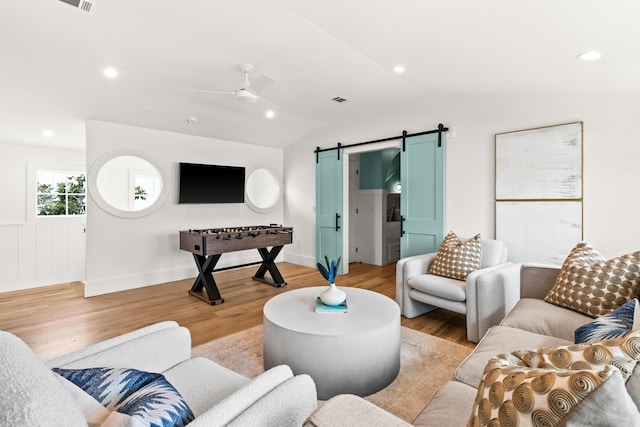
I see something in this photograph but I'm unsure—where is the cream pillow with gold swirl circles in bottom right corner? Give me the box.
[467,332,640,426]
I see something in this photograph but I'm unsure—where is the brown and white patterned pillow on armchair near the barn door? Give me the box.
[428,231,482,280]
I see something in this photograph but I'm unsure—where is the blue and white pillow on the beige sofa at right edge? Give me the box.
[574,298,640,344]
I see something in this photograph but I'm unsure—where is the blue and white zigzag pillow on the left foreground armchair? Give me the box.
[53,368,195,427]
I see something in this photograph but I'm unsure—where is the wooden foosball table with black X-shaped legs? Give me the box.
[180,224,293,305]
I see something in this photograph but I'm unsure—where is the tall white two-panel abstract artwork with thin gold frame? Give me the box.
[495,122,583,265]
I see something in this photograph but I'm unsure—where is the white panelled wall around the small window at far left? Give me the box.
[0,144,86,292]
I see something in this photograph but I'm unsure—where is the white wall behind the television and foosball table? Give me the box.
[85,120,284,296]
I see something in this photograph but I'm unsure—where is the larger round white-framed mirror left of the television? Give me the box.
[88,152,167,218]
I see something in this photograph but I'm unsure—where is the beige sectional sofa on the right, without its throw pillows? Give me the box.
[305,264,640,427]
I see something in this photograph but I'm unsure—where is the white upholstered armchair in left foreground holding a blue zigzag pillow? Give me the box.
[0,321,317,427]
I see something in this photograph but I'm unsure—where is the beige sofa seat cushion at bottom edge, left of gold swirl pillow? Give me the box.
[412,381,478,427]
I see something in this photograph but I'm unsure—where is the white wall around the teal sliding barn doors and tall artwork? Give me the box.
[284,95,640,267]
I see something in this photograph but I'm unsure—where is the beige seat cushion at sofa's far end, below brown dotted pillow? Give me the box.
[500,298,593,342]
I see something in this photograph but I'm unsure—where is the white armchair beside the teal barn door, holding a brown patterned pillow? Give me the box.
[396,239,517,343]
